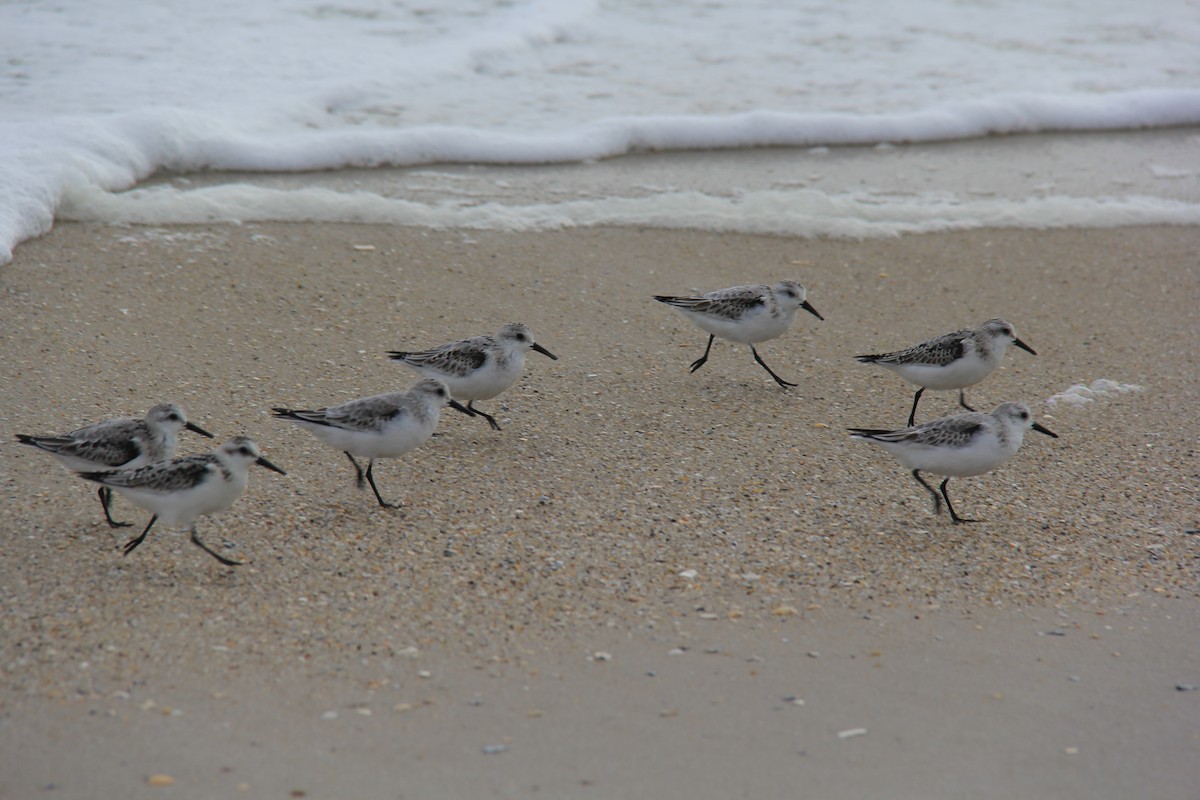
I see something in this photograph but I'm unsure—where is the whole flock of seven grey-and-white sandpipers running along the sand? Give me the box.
[17,281,1057,566]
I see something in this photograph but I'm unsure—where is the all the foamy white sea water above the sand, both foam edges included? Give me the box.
[0,0,1200,261]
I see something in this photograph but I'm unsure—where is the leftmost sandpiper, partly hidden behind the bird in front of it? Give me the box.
[17,403,212,528]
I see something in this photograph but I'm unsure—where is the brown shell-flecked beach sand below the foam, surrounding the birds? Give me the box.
[0,215,1200,799]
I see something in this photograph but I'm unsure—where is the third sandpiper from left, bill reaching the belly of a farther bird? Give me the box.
[271,378,469,509]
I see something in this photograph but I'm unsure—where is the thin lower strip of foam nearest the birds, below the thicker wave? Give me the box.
[61,184,1200,239]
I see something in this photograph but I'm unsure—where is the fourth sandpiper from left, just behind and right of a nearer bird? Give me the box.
[388,323,558,431]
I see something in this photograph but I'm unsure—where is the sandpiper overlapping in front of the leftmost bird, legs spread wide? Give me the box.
[79,437,287,566]
